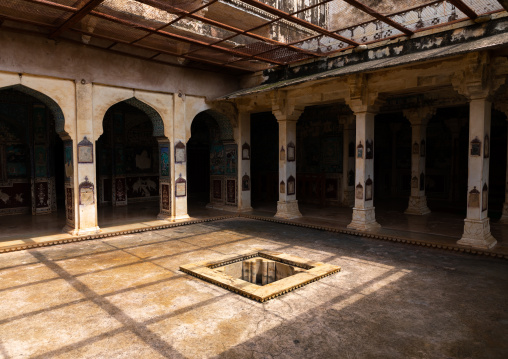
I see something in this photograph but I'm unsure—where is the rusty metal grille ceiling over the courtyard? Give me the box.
[0,0,508,72]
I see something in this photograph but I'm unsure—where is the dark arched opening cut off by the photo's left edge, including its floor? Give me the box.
[0,85,67,239]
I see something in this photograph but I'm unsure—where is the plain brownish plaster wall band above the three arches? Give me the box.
[0,31,239,99]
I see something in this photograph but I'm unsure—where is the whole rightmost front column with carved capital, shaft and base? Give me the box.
[452,53,504,248]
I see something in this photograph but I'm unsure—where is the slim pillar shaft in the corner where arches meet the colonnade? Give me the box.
[235,112,252,212]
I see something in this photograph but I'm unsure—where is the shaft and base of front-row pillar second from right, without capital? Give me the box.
[347,106,381,231]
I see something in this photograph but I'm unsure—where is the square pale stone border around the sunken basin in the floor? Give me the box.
[180,249,341,303]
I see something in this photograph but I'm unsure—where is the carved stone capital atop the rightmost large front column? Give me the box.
[452,52,506,101]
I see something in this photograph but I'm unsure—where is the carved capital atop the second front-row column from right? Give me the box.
[346,74,383,115]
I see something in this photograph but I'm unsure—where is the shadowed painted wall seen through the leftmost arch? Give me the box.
[0,89,60,215]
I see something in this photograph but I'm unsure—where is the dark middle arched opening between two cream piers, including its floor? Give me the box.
[96,98,170,227]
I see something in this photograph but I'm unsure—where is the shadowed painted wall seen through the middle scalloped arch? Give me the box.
[96,103,159,204]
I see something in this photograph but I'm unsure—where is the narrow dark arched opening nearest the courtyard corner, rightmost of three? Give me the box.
[187,111,238,214]
